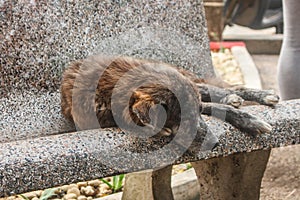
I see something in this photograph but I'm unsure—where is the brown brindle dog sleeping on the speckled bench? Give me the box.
[61,56,279,138]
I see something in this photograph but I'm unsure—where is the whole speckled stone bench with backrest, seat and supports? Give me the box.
[0,0,300,199]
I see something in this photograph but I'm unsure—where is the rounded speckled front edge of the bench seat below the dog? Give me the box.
[0,100,300,196]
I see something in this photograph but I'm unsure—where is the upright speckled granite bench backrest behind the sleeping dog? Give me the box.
[0,0,213,97]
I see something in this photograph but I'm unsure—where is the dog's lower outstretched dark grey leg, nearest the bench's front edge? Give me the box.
[202,102,272,135]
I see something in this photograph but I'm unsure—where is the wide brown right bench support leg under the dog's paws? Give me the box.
[192,150,271,200]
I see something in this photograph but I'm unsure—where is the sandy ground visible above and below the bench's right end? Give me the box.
[252,55,300,200]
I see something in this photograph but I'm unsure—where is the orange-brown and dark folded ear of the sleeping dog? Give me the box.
[132,91,154,125]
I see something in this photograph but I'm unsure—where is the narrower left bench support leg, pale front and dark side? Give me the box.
[122,166,173,200]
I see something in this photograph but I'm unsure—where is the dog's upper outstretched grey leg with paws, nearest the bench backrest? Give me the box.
[197,83,279,107]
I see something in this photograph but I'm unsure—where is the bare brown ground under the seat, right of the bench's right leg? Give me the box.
[261,145,300,200]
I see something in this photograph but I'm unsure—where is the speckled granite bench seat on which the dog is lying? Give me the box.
[0,90,300,196]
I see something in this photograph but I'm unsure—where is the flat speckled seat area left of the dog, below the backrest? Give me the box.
[0,92,75,142]
